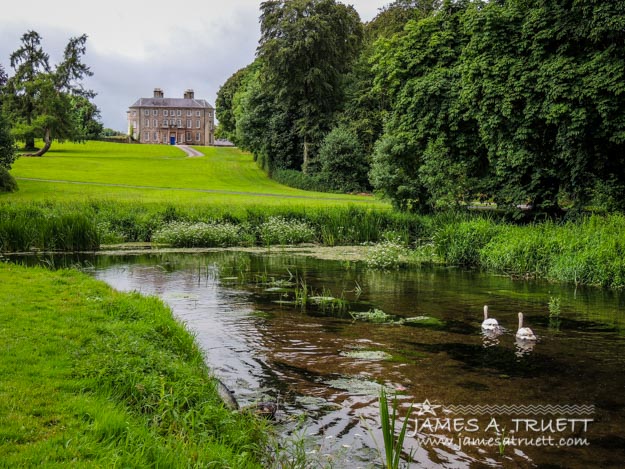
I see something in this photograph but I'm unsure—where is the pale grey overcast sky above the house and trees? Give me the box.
[0,0,390,131]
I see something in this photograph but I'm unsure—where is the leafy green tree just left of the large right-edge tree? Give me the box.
[371,1,484,211]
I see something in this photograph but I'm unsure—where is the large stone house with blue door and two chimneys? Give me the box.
[128,88,215,145]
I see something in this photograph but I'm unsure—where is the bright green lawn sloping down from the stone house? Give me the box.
[7,142,385,207]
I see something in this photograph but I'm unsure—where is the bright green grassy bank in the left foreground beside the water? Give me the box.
[0,264,262,468]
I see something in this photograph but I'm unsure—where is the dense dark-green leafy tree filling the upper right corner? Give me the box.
[463,0,625,213]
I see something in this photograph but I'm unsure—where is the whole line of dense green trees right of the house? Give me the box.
[216,0,625,215]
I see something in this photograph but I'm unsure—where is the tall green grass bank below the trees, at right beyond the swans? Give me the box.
[434,214,625,288]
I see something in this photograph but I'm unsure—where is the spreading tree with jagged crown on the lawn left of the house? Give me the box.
[3,31,95,156]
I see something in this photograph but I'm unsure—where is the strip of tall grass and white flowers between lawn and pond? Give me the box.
[0,200,427,252]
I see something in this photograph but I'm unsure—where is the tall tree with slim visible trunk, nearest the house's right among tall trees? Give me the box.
[258,0,362,171]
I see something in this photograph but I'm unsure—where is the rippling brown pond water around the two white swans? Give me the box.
[9,247,625,468]
